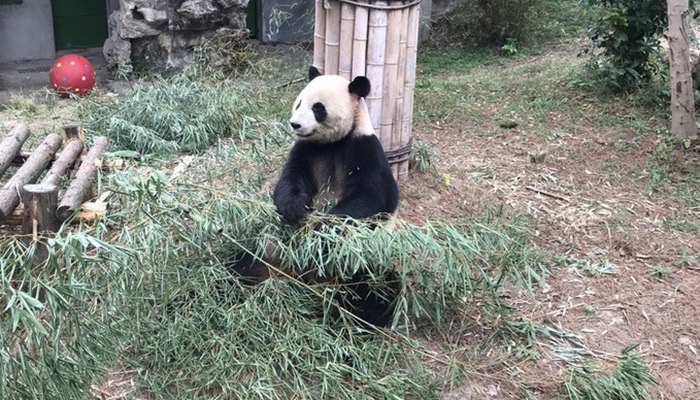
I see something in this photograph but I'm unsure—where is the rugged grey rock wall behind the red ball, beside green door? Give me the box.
[103,0,248,73]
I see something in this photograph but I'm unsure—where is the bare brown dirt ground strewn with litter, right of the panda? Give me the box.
[402,111,700,400]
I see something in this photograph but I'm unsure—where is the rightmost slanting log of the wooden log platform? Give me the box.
[56,136,107,221]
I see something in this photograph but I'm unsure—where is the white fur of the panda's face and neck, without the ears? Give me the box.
[289,75,366,143]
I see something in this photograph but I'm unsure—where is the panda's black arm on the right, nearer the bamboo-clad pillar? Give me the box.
[329,135,399,219]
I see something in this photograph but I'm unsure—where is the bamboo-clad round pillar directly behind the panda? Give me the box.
[313,0,420,180]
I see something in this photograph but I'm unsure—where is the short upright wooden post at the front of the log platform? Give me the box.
[22,184,60,265]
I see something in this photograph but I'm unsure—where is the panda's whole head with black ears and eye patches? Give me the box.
[289,67,373,143]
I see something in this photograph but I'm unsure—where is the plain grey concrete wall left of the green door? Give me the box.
[0,0,56,63]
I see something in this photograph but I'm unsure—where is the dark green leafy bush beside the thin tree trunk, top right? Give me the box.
[585,0,667,89]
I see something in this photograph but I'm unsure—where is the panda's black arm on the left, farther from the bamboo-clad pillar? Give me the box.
[272,142,318,224]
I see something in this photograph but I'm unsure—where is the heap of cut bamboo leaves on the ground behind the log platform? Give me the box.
[78,69,292,155]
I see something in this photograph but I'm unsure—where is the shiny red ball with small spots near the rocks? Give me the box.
[49,54,95,96]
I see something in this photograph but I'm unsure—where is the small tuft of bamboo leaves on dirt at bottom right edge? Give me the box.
[560,346,656,400]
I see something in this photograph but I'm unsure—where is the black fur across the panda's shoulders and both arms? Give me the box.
[273,134,399,224]
